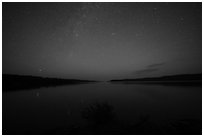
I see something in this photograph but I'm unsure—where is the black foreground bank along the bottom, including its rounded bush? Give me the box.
[3,103,202,135]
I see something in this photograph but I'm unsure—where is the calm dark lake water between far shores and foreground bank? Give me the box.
[2,83,202,134]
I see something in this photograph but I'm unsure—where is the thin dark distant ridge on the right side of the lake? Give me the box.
[110,74,202,82]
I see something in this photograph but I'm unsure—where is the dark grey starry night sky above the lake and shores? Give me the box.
[2,2,202,80]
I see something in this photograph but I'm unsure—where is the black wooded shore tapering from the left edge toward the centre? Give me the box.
[2,74,94,91]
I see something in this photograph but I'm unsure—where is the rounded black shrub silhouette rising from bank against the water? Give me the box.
[82,103,114,125]
